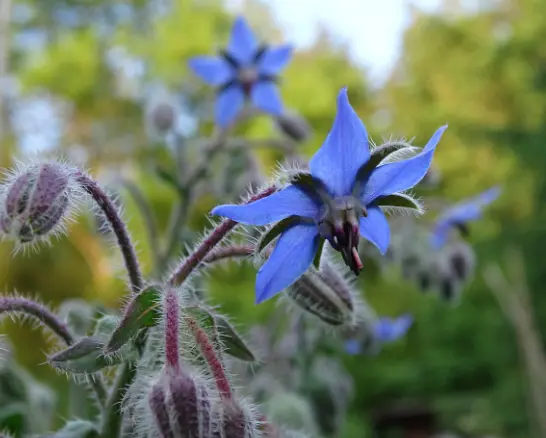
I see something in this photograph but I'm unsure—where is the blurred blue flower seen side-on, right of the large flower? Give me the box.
[430,187,501,249]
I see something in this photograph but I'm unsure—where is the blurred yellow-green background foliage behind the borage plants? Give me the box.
[0,0,546,437]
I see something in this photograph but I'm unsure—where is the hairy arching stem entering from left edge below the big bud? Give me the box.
[0,297,106,406]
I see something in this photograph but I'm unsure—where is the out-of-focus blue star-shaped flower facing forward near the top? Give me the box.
[189,17,292,127]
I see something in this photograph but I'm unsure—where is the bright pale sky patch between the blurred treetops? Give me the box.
[226,0,441,84]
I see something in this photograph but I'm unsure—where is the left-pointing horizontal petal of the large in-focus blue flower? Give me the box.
[211,186,319,225]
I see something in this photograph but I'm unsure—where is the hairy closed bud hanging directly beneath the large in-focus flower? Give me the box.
[286,263,355,326]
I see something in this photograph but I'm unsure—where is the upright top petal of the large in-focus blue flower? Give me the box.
[309,88,370,196]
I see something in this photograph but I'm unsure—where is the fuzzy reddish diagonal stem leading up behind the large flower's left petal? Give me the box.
[168,186,276,286]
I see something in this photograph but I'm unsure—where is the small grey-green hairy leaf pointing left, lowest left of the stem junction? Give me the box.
[48,337,127,374]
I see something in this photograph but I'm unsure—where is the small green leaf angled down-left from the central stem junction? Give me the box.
[105,285,161,353]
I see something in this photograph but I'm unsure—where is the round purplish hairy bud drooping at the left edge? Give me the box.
[0,162,77,244]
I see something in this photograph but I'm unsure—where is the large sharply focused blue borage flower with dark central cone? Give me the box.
[212,88,447,303]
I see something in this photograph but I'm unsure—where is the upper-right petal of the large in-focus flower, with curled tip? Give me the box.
[361,125,447,205]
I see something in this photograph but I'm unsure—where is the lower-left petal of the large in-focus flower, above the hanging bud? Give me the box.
[256,224,320,304]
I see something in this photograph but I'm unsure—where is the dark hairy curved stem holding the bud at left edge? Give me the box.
[76,172,143,293]
